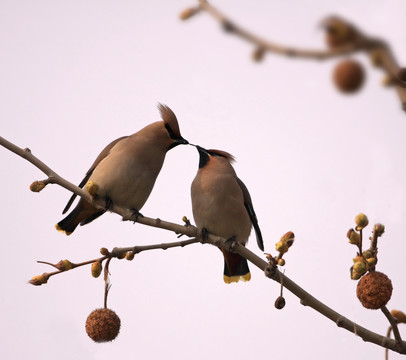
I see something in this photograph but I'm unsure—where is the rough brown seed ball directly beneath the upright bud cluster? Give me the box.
[357,271,393,309]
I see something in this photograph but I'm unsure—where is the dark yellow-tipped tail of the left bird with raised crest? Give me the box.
[55,200,105,235]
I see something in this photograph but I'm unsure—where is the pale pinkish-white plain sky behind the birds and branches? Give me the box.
[0,0,406,360]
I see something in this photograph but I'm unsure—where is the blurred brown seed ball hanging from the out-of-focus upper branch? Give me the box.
[333,59,365,94]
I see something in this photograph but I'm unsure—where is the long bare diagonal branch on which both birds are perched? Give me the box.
[0,137,406,354]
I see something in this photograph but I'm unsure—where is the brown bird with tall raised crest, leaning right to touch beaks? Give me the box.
[55,104,188,235]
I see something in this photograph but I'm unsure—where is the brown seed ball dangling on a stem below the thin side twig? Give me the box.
[86,309,121,342]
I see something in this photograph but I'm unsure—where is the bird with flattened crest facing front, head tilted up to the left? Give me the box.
[191,146,264,284]
